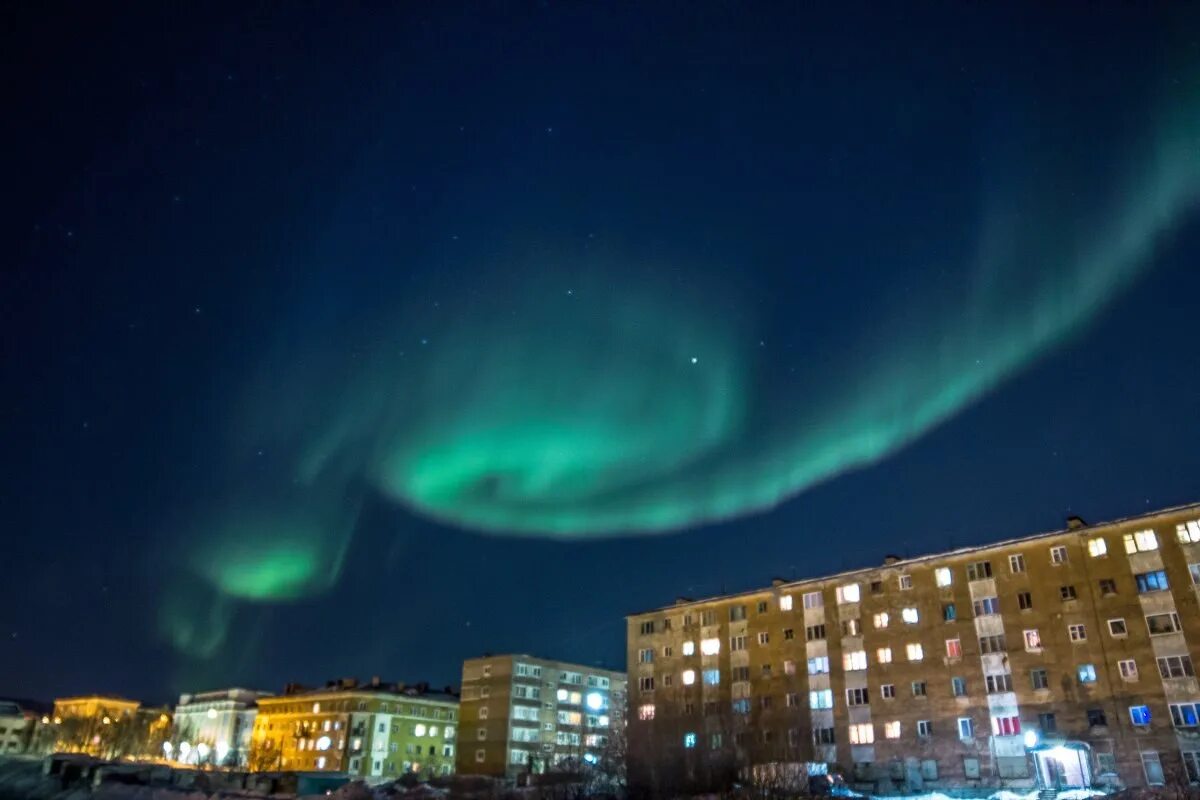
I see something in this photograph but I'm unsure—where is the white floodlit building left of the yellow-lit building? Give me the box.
[171,688,270,766]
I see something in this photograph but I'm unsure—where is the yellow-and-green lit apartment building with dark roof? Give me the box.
[248,678,458,781]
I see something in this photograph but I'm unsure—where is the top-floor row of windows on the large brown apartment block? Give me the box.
[641,519,1200,634]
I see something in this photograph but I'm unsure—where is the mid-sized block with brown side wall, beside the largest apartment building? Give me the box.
[458,655,626,778]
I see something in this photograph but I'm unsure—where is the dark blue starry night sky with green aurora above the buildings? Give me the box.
[0,2,1200,702]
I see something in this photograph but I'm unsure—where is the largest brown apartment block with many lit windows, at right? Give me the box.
[624,504,1200,789]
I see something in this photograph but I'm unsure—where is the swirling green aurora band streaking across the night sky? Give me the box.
[177,73,1200,623]
